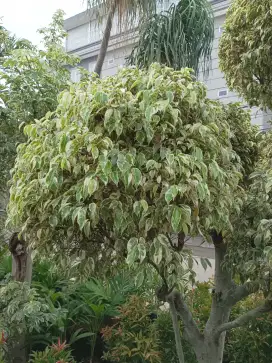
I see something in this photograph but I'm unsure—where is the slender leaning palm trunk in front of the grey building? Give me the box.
[94,0,117,77]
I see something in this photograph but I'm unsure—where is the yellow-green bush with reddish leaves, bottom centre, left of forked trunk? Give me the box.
[102,295,161,363]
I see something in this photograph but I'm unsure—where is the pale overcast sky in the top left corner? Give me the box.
[0,0,86,44]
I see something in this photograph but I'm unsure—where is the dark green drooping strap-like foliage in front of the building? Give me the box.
[128,0,214,73]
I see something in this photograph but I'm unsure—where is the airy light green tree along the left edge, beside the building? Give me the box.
[0,11,78,280]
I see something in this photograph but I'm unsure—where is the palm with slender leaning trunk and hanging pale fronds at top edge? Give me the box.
[87,0,160,76]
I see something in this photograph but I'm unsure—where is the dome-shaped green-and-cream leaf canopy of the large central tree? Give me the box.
[9,65,244,278]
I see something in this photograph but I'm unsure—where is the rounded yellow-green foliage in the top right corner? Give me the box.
[219,0,272,109]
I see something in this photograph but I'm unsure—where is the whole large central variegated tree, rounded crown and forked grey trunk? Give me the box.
[9,64,271,363]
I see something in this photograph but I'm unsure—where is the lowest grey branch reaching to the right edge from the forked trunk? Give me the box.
[215,300,272,338]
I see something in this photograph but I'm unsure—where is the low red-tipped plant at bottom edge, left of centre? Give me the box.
[30,338,75,363]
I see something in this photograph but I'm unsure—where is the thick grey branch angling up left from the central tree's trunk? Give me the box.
[168,291,203,346]
